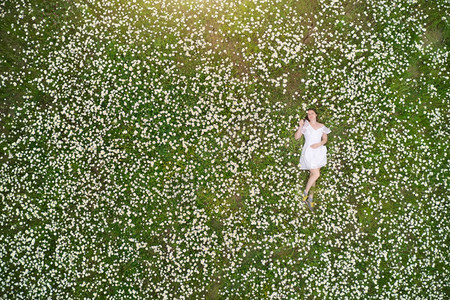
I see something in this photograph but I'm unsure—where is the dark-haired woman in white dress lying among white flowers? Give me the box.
[295,108,331,211]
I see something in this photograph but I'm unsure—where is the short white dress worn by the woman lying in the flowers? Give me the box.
[299,120,331,170]
